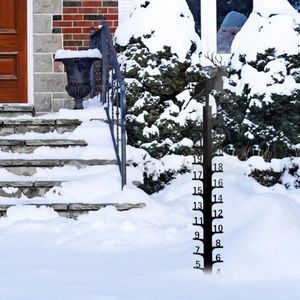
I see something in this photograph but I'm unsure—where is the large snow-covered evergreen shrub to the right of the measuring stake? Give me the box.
[220,0,300,158]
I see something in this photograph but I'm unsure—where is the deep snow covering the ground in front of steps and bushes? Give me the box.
[0,156,300,300]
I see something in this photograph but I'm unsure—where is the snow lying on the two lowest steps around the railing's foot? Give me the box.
[0,165,148,204]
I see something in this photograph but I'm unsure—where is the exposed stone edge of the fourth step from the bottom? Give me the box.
[0,139,87,153]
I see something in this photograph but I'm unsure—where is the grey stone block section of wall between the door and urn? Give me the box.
[33,0,74,114]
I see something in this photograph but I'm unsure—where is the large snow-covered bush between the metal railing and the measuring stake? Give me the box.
[116,0,204,158]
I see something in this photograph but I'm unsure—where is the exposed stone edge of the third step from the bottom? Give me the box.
[0,159,118,176]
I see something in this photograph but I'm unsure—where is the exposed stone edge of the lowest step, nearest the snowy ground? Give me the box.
[0,203,146,219]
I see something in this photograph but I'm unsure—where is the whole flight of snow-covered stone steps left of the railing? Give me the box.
[0,99,148,217]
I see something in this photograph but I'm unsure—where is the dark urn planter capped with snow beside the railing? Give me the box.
[54,49,102,109]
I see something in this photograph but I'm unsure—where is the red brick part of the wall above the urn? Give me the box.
[52,0,118,50]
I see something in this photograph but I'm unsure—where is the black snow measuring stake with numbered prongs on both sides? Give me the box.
[192,71,223,274]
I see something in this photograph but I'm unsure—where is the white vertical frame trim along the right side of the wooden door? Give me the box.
[27,0,34,105]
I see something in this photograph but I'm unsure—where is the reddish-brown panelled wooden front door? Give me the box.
[0,0,27,103]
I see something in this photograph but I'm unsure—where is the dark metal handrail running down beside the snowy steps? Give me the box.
[90,18,126,189]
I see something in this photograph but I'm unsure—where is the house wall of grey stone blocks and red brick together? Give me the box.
[29,0,118,114]
